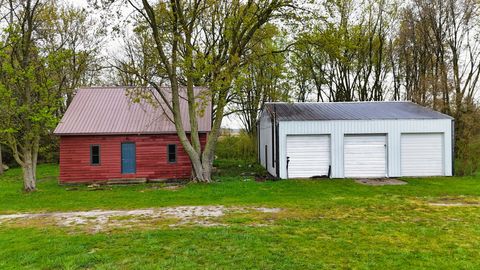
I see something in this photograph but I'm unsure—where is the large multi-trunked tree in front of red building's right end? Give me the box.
[113,0,291,182]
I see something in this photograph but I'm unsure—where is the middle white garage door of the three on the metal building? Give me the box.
[344,135,387,177]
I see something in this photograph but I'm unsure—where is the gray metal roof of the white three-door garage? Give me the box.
[265,101,453,121]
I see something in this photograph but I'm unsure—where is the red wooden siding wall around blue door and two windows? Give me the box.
[60,134,206,183]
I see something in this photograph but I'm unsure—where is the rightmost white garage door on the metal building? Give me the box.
[401,133,444,176]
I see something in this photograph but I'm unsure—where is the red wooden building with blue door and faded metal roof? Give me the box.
[54,87,211,183]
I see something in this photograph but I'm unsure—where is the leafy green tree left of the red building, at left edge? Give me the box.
[0,0,101,192]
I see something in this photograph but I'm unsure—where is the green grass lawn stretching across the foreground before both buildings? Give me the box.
[0,161,480,269]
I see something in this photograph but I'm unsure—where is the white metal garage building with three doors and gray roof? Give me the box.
[257,102,454,179]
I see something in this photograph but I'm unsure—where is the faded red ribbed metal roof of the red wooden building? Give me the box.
[54,87,211,135]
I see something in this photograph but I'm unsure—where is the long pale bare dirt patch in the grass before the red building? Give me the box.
[0,205,281,233]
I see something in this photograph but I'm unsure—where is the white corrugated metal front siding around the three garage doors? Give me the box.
[278,119,452,178]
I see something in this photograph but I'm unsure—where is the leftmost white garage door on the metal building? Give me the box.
[287,135,330,178]
